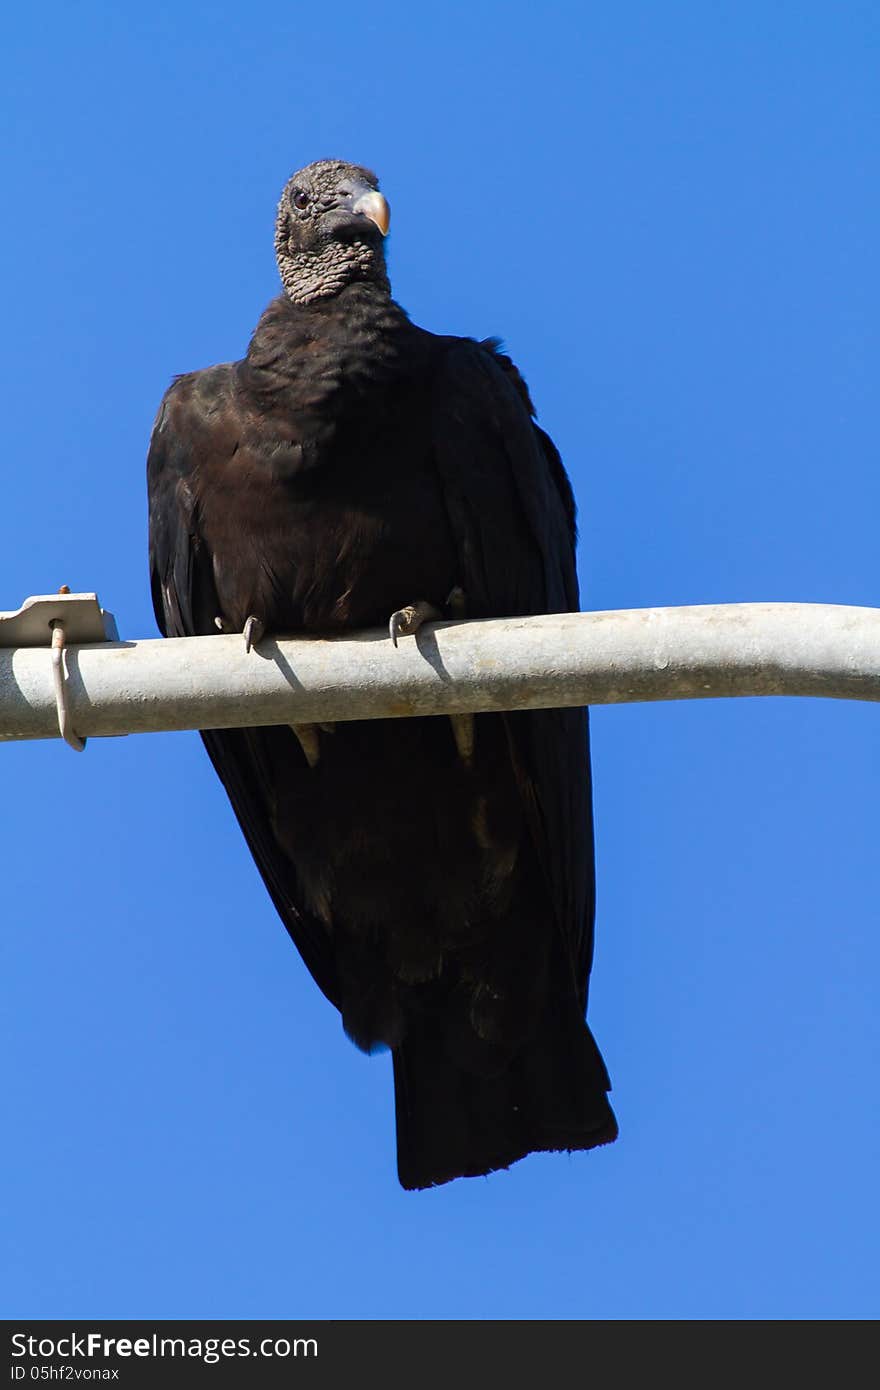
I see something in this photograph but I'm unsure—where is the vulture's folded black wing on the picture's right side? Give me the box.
[434,341,595,1006]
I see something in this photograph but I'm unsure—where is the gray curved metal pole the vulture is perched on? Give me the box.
[0,603,880,739]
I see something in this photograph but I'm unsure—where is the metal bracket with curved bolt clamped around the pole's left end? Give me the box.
[0,588,120,753]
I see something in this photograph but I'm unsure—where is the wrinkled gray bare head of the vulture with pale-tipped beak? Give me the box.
[275,160,389,304]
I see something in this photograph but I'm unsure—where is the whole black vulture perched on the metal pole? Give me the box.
[147,160,617,1188]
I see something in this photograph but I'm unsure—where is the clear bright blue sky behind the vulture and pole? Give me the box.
[0,0,880,1319]
